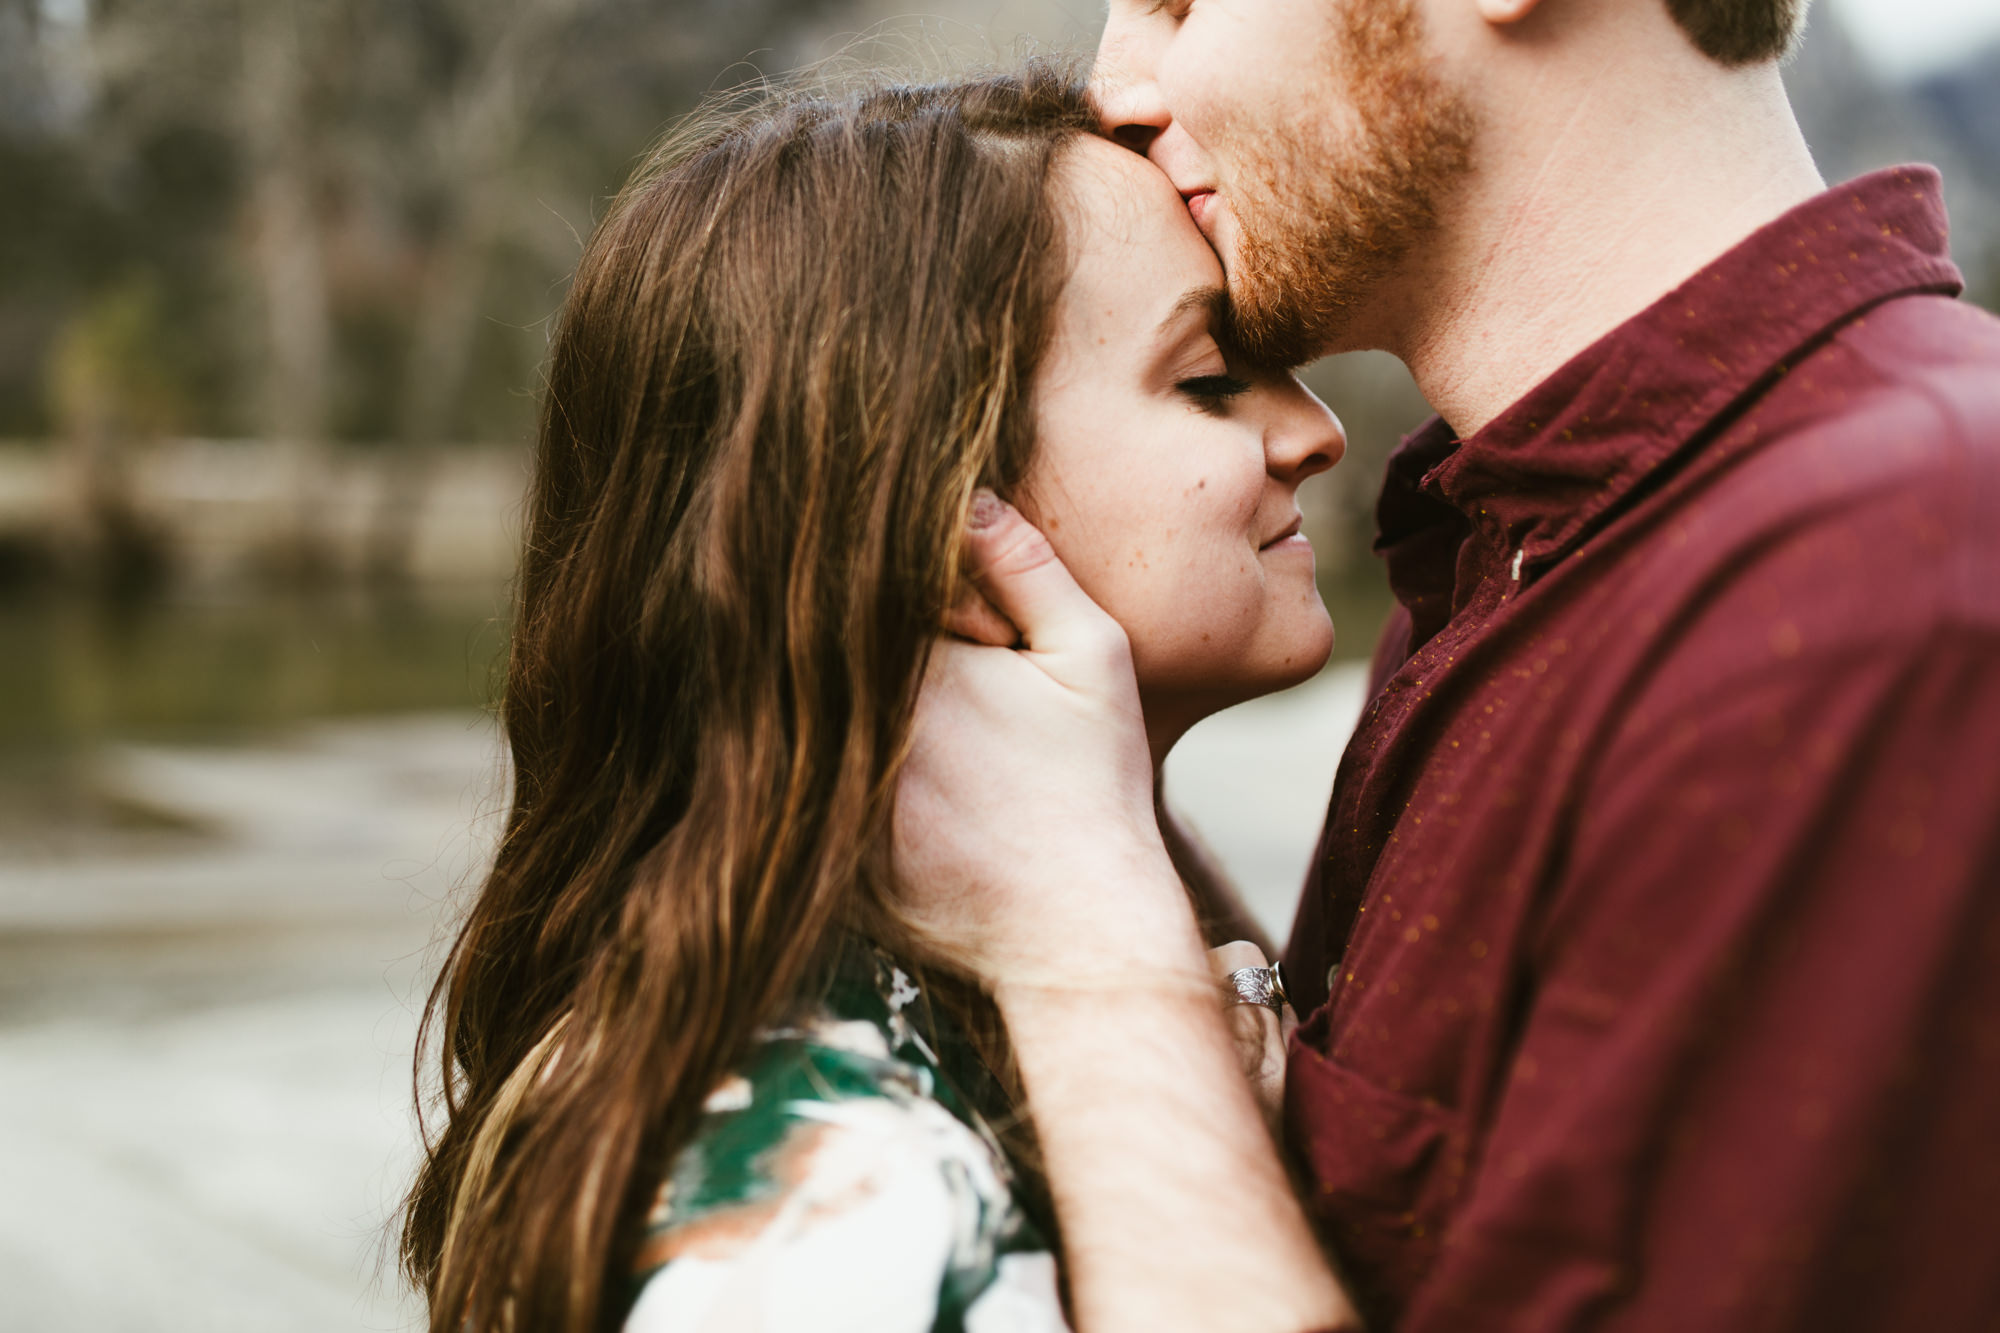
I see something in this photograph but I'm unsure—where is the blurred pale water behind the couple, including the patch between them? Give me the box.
[0,594,1360,1333]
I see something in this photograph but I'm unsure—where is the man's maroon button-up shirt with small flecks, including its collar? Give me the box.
[1286,168,2000,1333]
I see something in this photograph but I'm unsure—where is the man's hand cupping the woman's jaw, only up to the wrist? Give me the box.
[896,492,1208,993]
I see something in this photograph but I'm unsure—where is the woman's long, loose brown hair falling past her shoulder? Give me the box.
[402,66,1090,1333]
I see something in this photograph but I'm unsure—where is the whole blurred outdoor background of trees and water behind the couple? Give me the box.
[0,0,2000,1331]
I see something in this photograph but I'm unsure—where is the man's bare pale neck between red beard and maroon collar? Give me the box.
[1374,50,1824,436]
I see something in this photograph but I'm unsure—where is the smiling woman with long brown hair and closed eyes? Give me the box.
[404,66,1342,1333]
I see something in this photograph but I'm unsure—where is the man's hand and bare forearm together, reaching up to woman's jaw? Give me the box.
[896,496,1354,1333]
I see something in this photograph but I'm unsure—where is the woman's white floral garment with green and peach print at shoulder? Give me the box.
[624,949,1068,1333]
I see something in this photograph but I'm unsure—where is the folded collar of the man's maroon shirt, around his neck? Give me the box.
[1378,166,1962,578]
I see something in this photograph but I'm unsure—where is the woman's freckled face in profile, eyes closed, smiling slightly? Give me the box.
[1016,140,1346,743]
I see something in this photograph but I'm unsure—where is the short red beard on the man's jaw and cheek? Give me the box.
[1230,0,1474,366]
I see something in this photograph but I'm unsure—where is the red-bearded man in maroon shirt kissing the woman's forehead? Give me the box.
[896,0,2000,1333]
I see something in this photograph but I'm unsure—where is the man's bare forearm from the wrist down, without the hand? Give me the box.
[1000,876,1356,1333]
